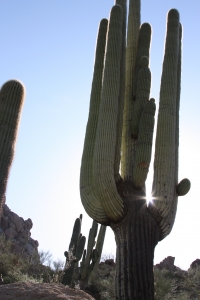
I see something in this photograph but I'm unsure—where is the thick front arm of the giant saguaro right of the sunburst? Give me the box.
[152,9,180,217]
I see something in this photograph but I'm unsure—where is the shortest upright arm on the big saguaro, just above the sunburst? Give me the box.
[133,99,156,187]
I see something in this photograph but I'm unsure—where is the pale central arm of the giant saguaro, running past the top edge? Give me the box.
[121,0,140,180]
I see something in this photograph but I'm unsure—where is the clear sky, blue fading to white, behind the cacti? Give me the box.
[0,0,200,269]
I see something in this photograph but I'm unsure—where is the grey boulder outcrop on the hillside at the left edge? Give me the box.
[0,204,39,257]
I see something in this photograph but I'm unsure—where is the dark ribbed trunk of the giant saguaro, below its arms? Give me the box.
[111,195,159,300]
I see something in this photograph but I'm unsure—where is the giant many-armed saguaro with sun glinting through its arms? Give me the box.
[80,0,190,300]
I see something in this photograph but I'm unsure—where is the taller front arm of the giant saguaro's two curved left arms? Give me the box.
[94,5,123,220]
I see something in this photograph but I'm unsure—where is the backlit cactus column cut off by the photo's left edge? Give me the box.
[0,80,25,220]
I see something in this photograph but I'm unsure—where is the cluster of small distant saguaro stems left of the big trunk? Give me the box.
[62,215,106,289]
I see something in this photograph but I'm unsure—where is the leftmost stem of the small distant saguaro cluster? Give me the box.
[62,215,86,287]
